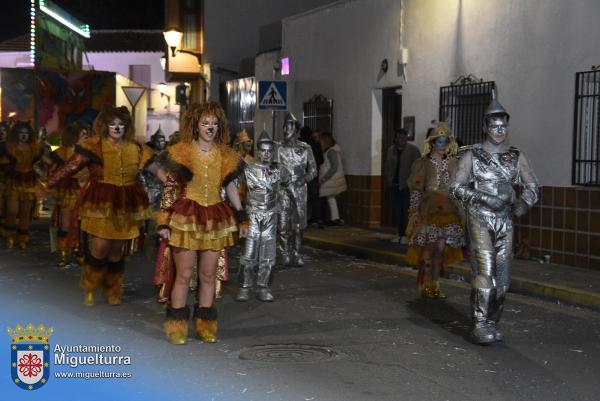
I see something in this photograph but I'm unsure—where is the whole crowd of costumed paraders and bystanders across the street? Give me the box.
[0,95,539,344]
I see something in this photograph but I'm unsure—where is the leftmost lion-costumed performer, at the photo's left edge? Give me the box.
[0,121,43,249]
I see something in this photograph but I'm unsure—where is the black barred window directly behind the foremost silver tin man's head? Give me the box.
[439,75,496,145]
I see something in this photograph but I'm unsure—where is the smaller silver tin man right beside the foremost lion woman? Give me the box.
[236,131,282,302]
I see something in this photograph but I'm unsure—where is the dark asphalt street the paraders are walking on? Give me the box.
[0,222,600,401]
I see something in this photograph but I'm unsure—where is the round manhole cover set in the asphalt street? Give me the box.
[238,344,339,363]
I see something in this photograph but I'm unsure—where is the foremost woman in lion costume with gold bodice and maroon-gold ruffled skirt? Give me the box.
[157,102,247,344]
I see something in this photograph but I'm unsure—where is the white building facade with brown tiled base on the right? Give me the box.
[276,0,600,267]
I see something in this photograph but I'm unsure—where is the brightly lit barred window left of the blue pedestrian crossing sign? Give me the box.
[221,77,256,142]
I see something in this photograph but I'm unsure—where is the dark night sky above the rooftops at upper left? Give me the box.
[0,0,164,41]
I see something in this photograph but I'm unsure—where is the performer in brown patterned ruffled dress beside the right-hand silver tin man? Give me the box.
[407,122,464,299]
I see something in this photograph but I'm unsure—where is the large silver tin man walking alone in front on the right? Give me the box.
[450,99,539,344]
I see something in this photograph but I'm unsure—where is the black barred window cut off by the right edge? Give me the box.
[571,66,600,186]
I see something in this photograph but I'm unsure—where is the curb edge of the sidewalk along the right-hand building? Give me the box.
[304,234,600,310]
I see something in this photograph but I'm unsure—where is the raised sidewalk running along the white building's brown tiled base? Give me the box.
[304,226,600,310]
